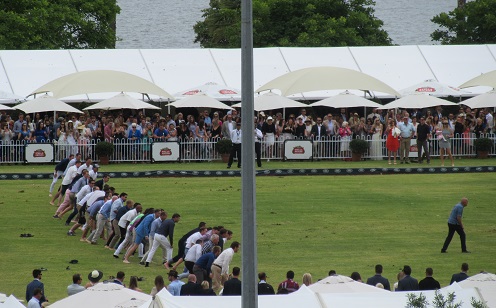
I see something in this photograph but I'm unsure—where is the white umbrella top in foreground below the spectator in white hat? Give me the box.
[50,283,151,308]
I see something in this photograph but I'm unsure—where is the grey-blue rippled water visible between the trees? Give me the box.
[117,0,457,49]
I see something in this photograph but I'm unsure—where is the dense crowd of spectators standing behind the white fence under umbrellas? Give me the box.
[0,106,495,161]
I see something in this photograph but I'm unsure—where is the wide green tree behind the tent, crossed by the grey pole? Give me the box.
[194,0,391,48]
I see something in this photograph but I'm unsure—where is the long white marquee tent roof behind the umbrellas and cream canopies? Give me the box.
[0,45,496,101]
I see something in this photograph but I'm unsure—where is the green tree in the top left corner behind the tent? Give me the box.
[0,0,120,49]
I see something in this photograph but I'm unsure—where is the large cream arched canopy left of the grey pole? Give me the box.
[30,70,174,99]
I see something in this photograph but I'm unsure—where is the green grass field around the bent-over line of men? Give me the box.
[0,165,496,302]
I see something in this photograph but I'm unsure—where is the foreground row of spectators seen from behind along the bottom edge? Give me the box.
[26,262,478,307]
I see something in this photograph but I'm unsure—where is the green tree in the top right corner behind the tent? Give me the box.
[431,0,496,45]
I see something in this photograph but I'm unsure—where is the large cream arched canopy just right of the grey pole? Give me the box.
[256,66,401,97]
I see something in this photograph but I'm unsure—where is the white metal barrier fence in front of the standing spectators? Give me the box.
[0,134,496,164]
